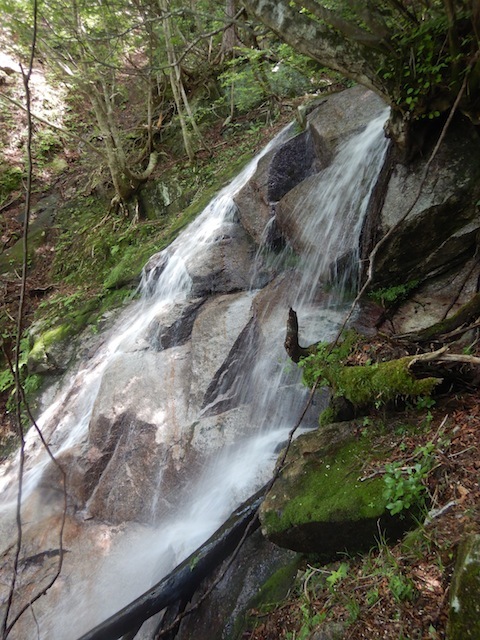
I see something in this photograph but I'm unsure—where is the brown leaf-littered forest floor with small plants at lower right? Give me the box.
[244,394,480,640]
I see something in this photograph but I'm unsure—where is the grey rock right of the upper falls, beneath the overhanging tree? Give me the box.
[372,122,480,288]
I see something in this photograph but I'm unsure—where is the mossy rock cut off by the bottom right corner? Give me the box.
[447,535,480,640]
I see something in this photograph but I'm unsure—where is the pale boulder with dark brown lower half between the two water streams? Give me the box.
[80,345,193,522]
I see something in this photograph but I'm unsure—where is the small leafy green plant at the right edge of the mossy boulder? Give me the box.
[383,442,435,515]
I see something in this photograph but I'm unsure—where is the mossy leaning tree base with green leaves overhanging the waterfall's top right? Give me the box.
[244,0,480,156]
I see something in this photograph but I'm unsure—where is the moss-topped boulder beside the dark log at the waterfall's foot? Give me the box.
[260,422,404,558]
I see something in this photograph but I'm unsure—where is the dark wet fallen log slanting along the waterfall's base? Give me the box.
[79,487,265,640]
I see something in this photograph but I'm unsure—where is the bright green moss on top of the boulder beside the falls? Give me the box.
[264,439,386,534]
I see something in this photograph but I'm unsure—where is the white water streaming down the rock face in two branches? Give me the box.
[0,114,387,640]
